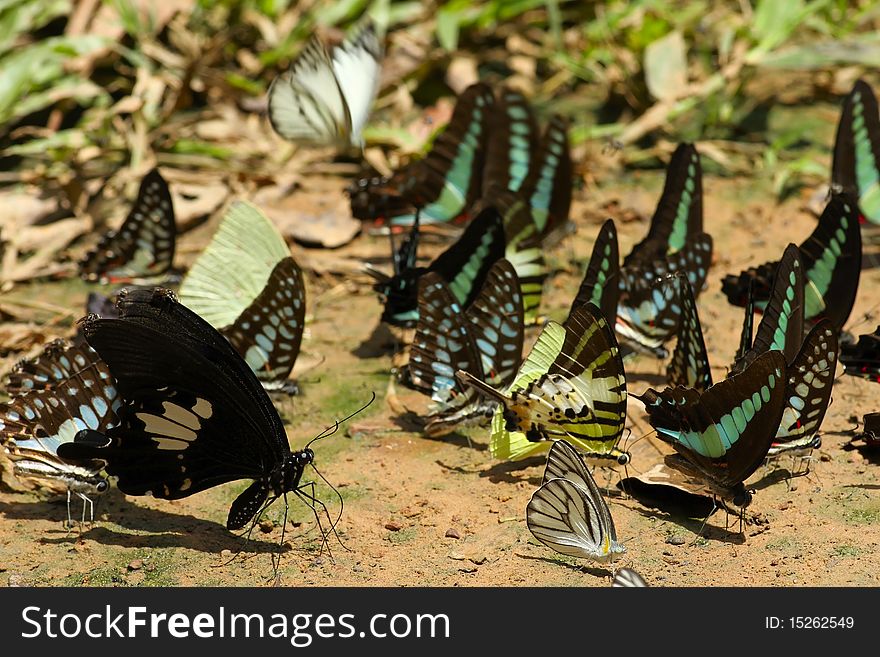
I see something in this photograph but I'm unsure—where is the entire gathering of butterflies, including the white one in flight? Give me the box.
[0,11,880,586]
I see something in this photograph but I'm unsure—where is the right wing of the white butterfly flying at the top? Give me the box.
[333,20,382,146]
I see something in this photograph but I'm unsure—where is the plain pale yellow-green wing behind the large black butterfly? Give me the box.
[180,201,290,329]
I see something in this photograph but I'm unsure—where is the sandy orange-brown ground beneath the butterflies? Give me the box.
[0,160,880,586]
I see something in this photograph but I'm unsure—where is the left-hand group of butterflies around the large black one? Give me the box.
[0,165,340,540]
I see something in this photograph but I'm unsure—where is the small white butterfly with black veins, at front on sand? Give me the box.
[526,440,626,563]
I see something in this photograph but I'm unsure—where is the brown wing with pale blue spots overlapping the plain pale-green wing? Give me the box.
[222,256,306,390]
